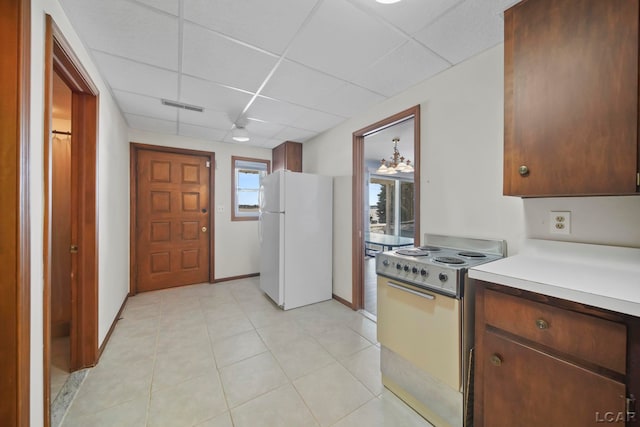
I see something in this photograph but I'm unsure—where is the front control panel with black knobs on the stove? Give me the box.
[376,253,463,296]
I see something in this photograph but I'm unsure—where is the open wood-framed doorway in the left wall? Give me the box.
[43,15,99,426]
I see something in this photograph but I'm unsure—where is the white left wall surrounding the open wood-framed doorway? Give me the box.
[29,0,129,426]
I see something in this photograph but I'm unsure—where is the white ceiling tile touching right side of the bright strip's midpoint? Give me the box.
[262,61,344,107]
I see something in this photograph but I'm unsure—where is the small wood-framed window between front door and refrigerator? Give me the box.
[231,156,271,221]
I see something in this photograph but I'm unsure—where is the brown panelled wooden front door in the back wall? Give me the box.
[133,149,213,292]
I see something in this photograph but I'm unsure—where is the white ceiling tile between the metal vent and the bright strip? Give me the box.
[180,75,253,117]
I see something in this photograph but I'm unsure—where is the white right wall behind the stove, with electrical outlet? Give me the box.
[303,45,640,301]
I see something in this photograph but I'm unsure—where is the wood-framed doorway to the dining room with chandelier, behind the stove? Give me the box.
[352,105,420,317]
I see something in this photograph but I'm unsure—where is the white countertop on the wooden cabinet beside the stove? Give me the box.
[469,239,640,317]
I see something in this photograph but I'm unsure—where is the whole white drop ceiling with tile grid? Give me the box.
[60,0,517,148]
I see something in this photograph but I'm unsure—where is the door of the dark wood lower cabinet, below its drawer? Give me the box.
[478,331,626,427]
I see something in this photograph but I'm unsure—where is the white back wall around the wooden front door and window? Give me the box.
[129,129,271,280]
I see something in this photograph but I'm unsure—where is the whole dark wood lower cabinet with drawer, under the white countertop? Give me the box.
[474,282,640,427]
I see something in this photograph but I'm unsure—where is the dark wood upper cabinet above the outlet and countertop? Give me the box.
[504,0,640,197]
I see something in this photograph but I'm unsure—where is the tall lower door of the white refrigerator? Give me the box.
[259,212,284,307]
